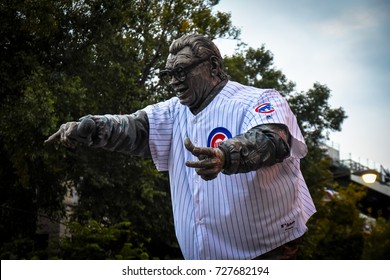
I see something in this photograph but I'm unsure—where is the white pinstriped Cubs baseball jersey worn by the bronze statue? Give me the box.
[144,81,315,259]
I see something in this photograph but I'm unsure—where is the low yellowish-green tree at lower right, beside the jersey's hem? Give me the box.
[300,181,366,260]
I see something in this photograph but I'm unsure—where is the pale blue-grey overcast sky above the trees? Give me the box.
[215,0,390,169]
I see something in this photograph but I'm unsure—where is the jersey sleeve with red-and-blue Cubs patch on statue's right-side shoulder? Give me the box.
[243,90,307,158]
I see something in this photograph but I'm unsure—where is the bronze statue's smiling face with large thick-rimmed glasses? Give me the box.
[166,47,216,109]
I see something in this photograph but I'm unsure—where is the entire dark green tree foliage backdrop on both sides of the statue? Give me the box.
[0,0,390,259]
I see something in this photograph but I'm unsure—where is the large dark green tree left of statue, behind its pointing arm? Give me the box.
[0,0,239,258]
